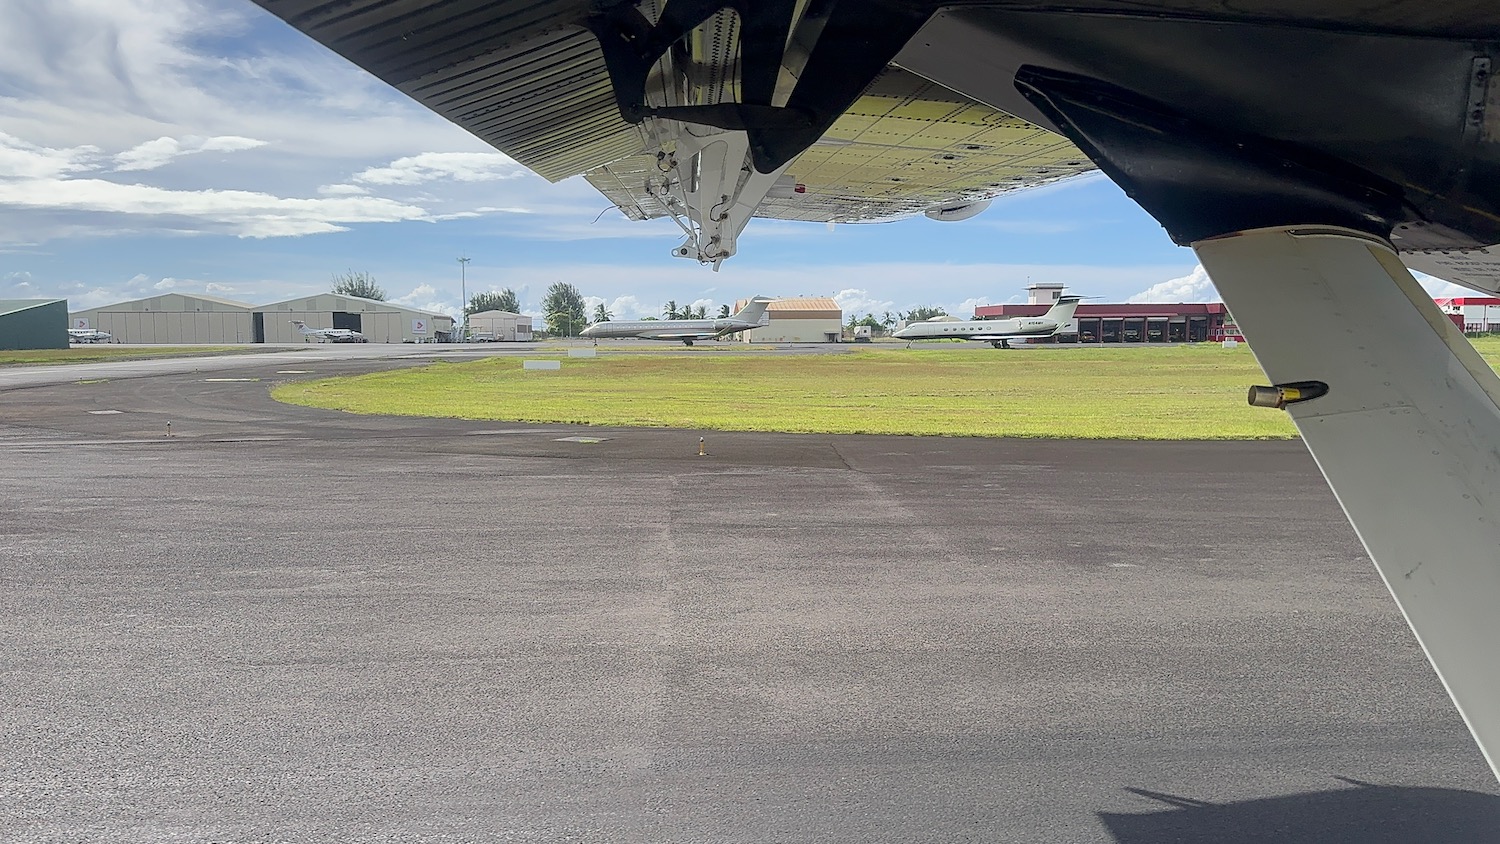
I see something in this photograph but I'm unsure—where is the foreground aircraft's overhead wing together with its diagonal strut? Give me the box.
[255,0,1500,768]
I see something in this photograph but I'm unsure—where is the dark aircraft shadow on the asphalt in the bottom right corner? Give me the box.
[1100,777,1500,844]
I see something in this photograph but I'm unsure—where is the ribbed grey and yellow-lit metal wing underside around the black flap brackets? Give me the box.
[246,0,1095,247]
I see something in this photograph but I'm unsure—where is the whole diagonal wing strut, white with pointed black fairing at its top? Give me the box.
[1016,66,1500,775]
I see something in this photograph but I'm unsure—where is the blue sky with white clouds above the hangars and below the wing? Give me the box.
[0,0,1470,318]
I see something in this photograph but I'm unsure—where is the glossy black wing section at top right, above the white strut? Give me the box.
[897,0,1500,260]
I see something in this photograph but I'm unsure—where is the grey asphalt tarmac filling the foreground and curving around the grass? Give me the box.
[0,346,1500,844]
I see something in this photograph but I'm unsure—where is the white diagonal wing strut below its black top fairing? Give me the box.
[1193,226,1500,775]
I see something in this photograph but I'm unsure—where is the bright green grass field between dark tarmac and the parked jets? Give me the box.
[272,339,1500,439]
